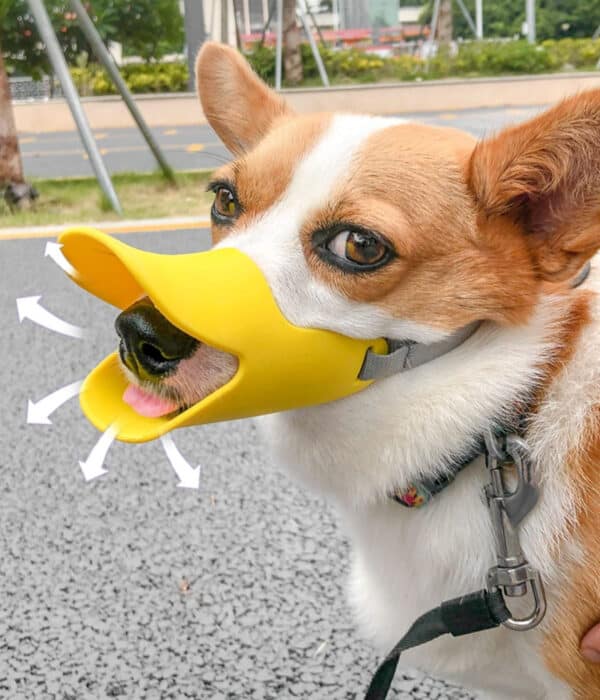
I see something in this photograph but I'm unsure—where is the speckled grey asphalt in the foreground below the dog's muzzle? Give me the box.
[0,231,476,700]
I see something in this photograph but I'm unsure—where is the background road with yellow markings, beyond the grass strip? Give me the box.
[20,107,540,177]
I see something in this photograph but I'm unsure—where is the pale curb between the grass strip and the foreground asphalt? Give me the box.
[0,217,210,241]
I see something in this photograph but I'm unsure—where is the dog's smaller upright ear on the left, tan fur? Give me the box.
[196,42,291,155]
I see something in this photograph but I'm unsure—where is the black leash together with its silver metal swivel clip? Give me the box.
[365,430,546,700]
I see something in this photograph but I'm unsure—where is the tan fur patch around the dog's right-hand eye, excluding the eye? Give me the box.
[302,124,538,329]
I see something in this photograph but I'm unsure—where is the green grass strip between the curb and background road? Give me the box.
[0,171,213,227]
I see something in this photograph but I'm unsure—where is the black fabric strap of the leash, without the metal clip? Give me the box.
[365,590,510,700]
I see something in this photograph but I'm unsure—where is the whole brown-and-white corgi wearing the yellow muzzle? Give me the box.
[117,43,600,700]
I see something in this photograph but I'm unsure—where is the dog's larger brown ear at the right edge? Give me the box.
[468,90,600,281]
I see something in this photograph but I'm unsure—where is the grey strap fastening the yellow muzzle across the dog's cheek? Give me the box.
[358,321,480,381]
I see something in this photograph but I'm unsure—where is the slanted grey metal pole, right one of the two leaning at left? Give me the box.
[71,0,175,182]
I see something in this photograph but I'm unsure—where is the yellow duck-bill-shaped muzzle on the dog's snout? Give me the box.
[59,228,387,442]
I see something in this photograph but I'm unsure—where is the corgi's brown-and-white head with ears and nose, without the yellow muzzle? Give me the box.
[117,44,600,416]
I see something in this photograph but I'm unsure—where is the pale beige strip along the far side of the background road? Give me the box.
[15,73,600,133]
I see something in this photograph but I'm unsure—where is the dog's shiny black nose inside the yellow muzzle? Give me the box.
[115,297,198,380]
